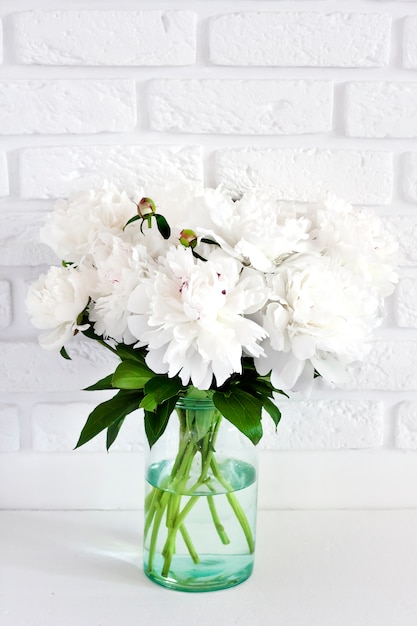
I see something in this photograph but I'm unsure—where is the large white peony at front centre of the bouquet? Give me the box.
[128,247,267,389]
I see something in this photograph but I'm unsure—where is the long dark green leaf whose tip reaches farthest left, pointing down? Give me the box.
[75,391,142,448]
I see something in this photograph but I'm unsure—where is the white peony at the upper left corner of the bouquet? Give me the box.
[40,184,137,264]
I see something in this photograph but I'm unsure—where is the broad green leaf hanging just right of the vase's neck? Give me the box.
[213,389,262,445]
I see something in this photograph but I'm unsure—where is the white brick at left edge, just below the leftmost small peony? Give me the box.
[0,338,118,393]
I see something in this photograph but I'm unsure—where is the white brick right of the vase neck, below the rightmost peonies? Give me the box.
[261,399,384,450]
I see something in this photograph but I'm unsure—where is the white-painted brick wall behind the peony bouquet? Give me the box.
[0,0,417,507]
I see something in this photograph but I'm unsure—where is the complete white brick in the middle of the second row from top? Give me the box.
[149,80,333,135]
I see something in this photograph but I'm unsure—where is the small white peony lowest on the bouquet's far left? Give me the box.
[26,267,94,350]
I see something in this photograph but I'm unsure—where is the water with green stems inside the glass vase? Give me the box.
[144,459,257,591]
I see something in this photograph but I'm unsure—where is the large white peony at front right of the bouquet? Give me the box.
[256,255,381,389]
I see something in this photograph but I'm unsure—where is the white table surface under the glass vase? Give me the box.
[0,510,417,626]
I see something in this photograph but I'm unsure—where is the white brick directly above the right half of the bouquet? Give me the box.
[216,148,393,204]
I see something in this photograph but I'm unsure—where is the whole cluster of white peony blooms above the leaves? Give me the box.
[27,185,397,390]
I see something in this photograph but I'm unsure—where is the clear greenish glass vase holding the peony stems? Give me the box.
[144,398,257,591]
